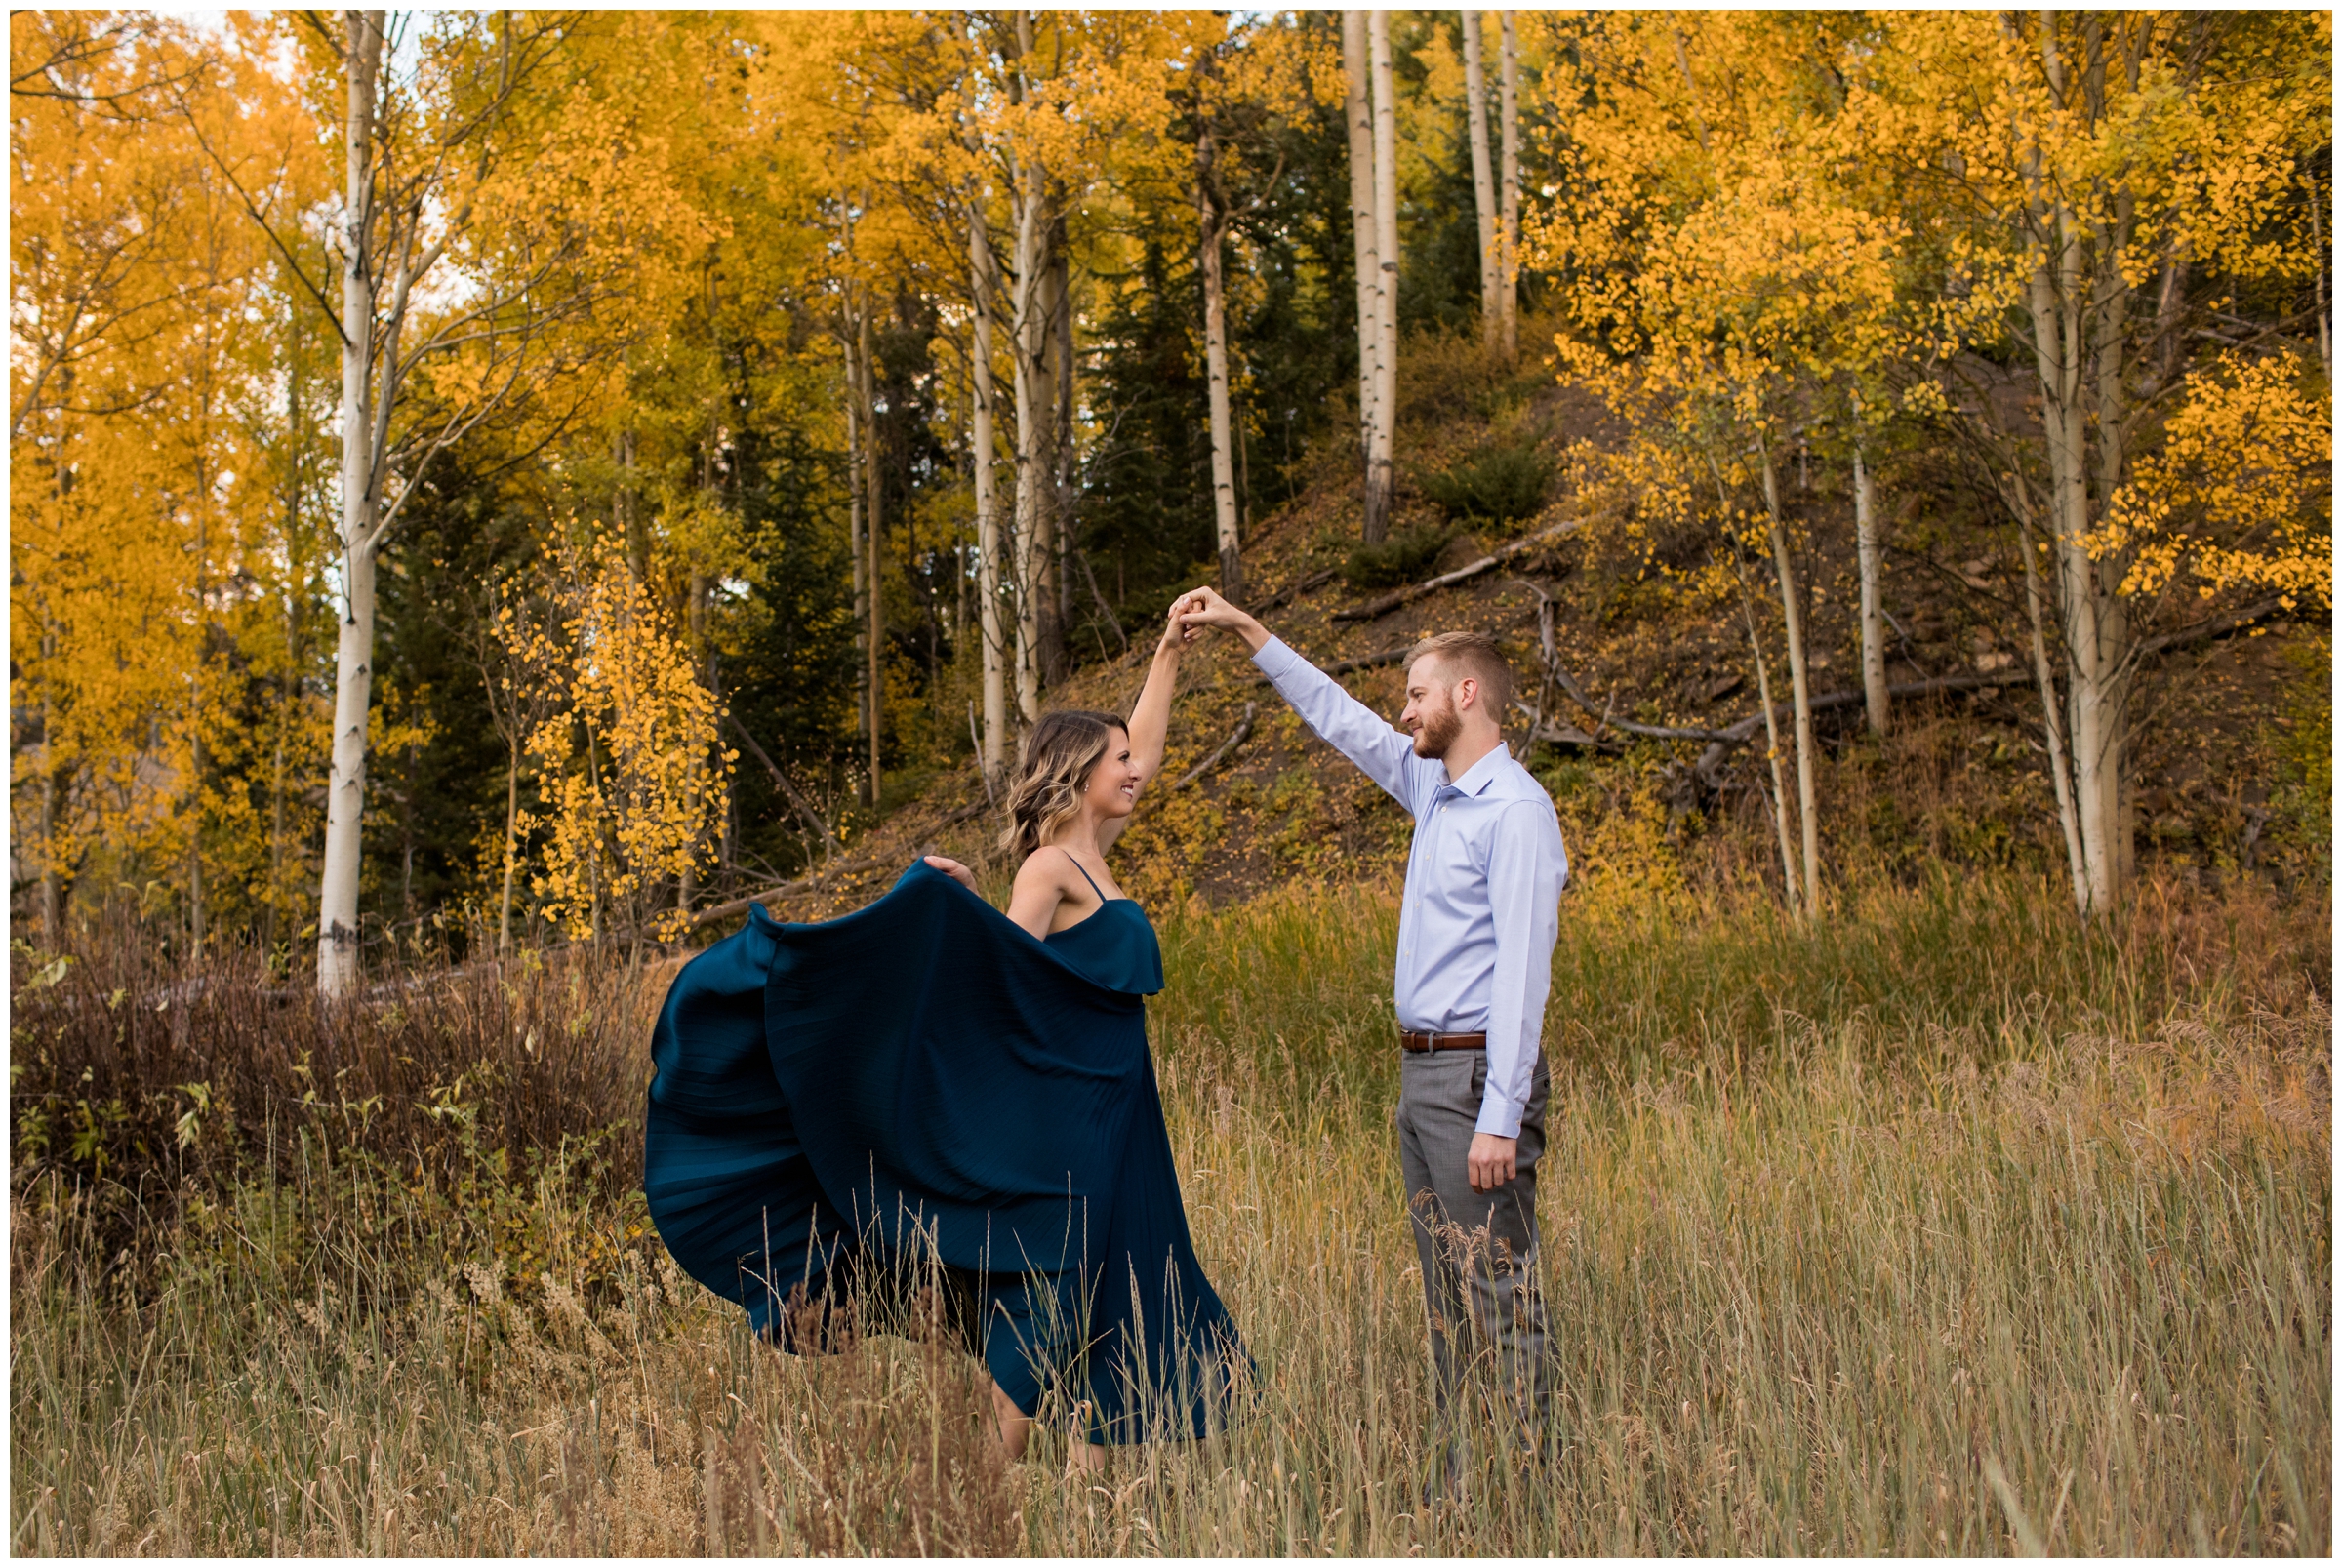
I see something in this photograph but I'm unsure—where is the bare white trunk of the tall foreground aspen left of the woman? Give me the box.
[316,12,382,999]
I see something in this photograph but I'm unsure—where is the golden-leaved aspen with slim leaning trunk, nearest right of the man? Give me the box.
[1526,17,1902,915]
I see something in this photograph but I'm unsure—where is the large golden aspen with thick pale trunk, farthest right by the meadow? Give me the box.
[1845,10,2332,917]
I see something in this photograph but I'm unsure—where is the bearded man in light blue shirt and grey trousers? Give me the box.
[1176,587,1569,1488]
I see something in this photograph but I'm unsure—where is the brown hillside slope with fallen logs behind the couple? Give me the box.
[766,342,2325,920]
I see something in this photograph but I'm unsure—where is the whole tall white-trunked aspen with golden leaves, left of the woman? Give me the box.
[187,10,705,999]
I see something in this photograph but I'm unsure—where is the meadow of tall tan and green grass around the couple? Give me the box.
[10,880,2332,1554]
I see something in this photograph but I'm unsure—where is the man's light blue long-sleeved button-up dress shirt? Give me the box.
[1253,636,1569,1138]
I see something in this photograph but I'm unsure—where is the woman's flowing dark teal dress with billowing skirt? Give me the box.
[642,862,1248,1441]
